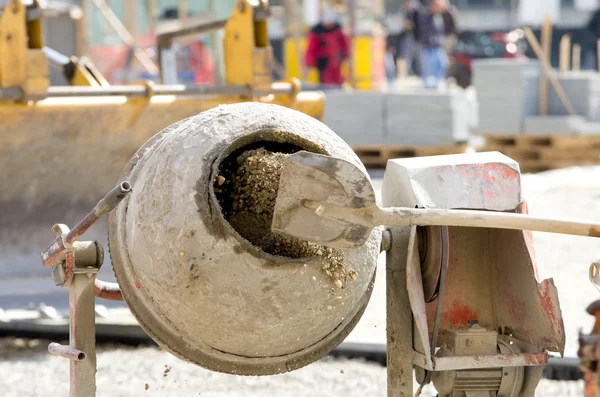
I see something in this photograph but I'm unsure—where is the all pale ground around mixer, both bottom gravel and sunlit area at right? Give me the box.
[0,167,600,397]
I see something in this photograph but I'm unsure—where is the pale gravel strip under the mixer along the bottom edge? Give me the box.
[0,340,583,397]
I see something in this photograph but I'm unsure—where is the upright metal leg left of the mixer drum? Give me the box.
[69,268,98,397]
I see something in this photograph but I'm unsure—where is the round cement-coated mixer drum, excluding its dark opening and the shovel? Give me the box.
[109,103,381,375]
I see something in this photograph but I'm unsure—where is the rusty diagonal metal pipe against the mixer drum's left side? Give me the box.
[42,181,131,268]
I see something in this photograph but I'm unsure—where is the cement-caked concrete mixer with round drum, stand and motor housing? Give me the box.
[42,103,597,397]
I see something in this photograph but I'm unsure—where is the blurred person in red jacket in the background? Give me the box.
[305,8,350,85]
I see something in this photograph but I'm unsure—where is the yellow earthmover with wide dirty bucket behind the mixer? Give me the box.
[0,0,324,275]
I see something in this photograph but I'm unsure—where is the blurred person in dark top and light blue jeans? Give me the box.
[410,0,457,88]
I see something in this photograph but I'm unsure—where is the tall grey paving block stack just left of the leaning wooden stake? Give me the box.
[472,59,541,135]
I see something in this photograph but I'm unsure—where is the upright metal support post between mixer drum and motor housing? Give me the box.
[386,227,413,397]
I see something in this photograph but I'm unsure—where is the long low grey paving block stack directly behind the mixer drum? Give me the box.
[323,89,478,146]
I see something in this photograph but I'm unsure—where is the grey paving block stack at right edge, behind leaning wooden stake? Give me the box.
[548,71,600,121]
